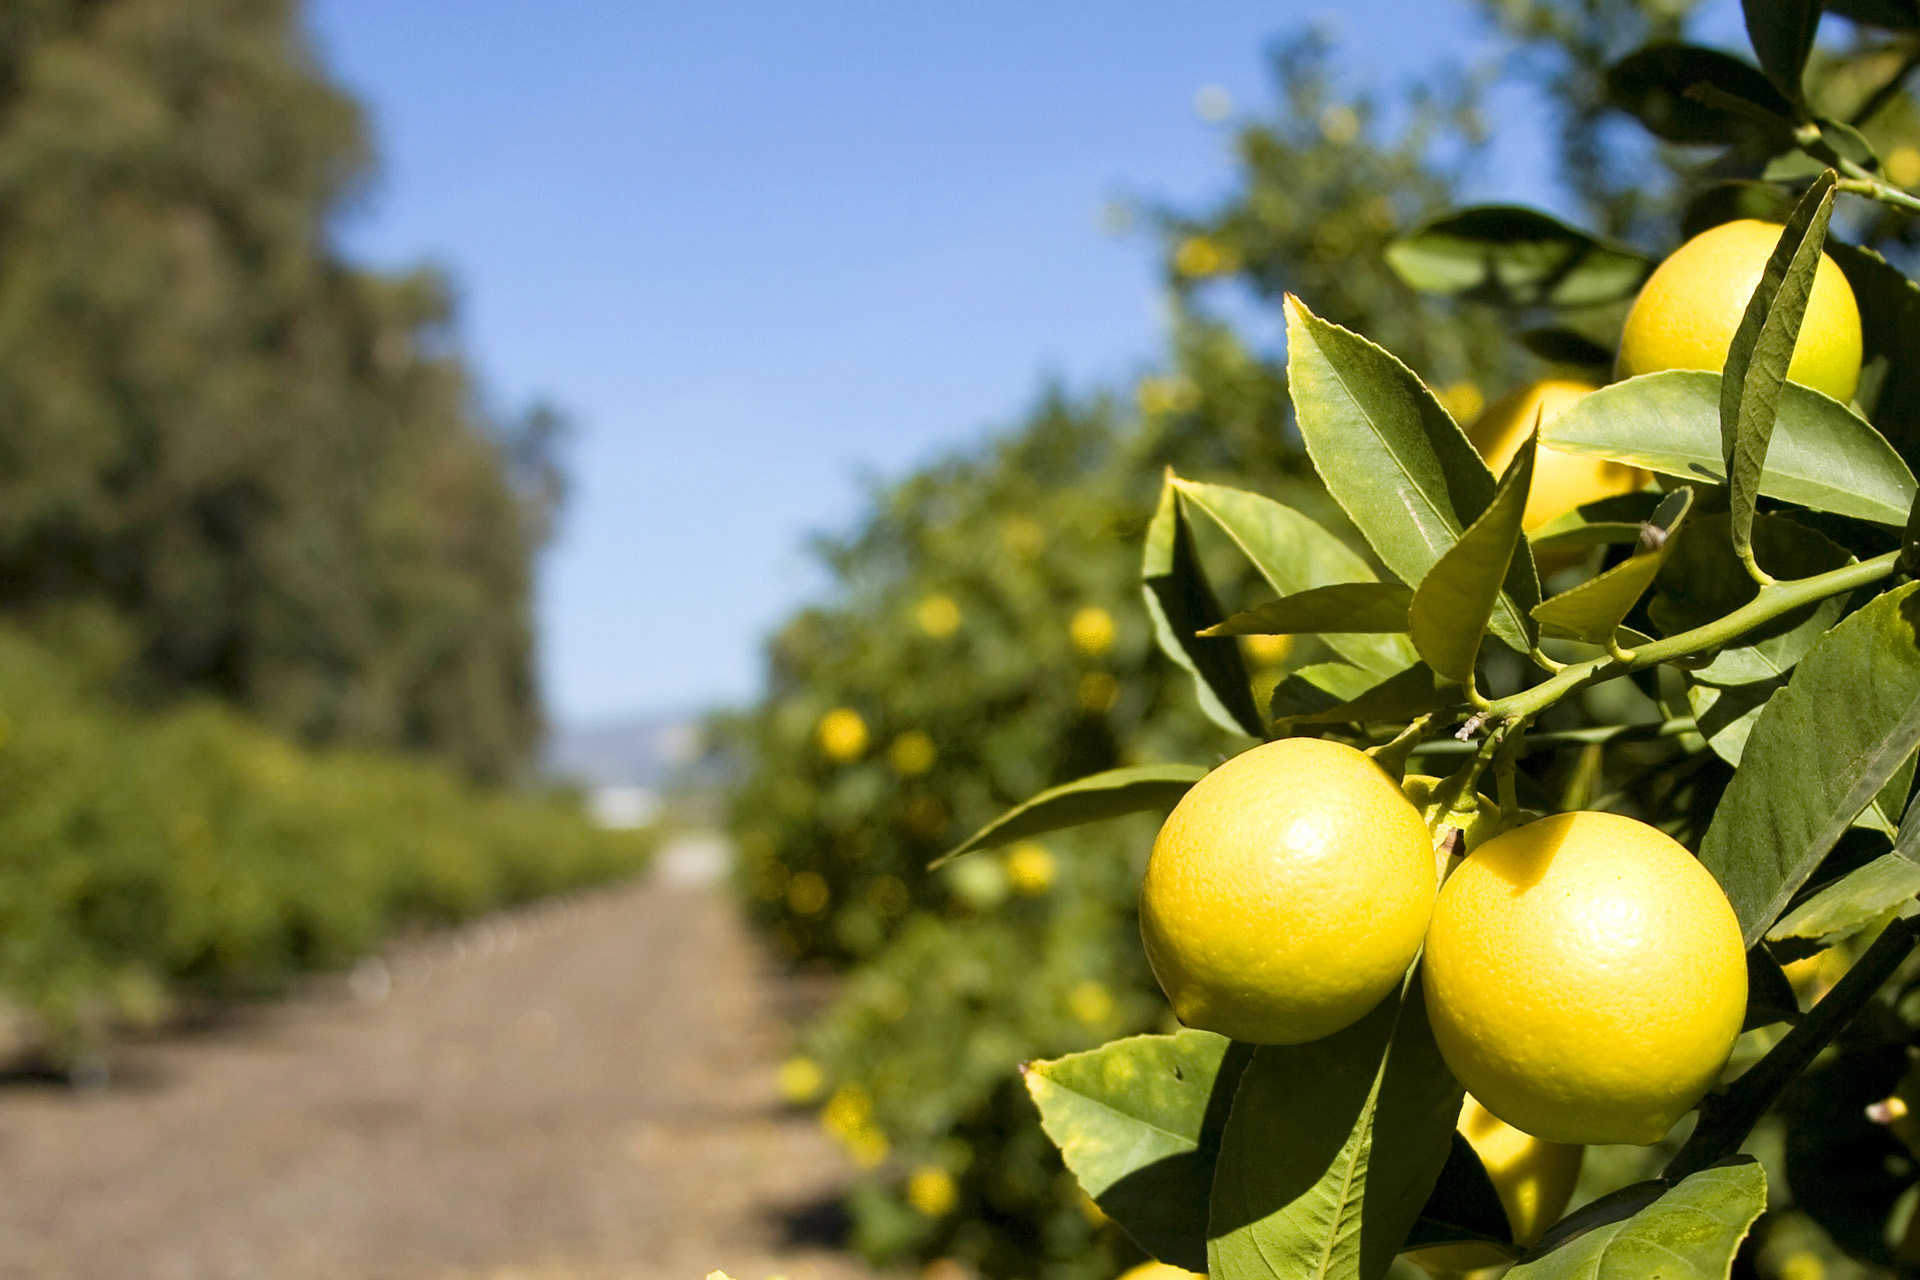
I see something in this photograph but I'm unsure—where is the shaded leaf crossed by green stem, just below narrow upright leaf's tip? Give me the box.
[1647,512,1853,685]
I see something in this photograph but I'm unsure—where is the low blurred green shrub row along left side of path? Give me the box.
[0,631,645,1050]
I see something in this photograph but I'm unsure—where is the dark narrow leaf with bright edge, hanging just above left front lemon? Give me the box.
[1140,472,1267,737]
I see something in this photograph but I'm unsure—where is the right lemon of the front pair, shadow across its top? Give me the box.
[1421,814,1747,1144]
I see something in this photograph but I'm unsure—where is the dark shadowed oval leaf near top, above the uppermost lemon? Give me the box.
[1607,44,1793,146]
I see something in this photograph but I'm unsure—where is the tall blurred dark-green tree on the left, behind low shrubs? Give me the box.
[0,0,557,779]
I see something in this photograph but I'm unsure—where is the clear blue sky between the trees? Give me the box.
[309,0,1574,723]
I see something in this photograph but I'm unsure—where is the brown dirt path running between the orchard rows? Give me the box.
[0,850,860,1280]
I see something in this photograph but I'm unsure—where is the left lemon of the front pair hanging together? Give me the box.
[1140,737,1436,1044]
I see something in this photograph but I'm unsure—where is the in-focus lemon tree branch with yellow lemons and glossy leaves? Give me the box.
[948,0,1920,1280]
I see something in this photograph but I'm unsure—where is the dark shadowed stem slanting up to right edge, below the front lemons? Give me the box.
[1661,919,1920,1182]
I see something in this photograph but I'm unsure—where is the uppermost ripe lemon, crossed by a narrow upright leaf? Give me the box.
[1615,219,1860,401]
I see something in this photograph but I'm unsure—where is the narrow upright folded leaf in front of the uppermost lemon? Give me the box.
[1720,171,1834,572]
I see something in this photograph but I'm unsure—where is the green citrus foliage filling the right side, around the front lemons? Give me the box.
[735,2,1920,1278]
